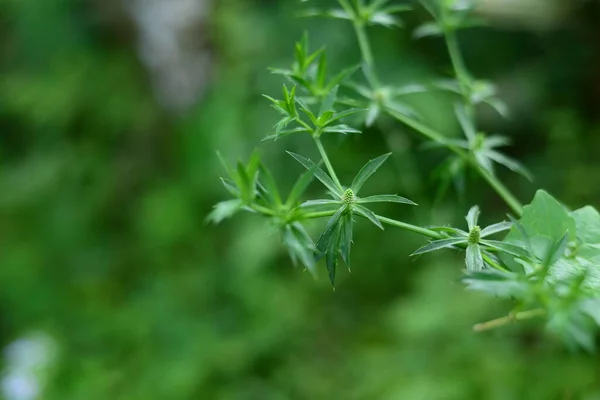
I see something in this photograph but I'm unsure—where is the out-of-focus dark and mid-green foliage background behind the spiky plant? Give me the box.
[0,0,600,400]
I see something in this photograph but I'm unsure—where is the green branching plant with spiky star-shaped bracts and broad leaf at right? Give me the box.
[208,0,600,350]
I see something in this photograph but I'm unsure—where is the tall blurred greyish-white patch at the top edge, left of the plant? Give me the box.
[123,0,211,111]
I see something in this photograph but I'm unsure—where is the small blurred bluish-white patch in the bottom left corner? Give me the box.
[0,333,56,400]
